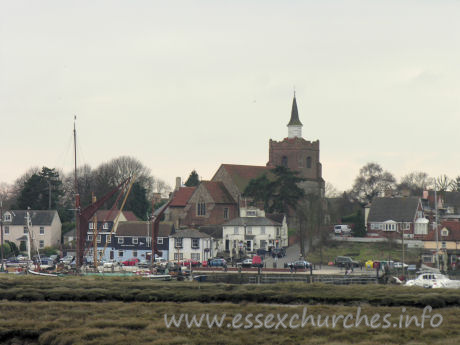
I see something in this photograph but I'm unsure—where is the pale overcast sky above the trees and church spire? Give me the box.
[0,0,460,190]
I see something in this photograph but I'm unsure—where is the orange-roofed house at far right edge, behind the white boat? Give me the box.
[422,220,460,269]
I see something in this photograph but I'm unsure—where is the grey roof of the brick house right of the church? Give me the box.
[367,197,419,222]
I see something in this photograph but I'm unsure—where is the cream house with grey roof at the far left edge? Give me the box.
[3,210,62,248]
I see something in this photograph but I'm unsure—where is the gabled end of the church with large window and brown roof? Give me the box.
[181,181,238,228]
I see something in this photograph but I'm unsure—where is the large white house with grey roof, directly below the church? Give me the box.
[222,208,288,257]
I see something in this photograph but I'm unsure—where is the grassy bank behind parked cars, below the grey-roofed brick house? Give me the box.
[307,240,420,264]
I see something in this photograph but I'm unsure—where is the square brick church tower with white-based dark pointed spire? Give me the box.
[267,95,324,196]
